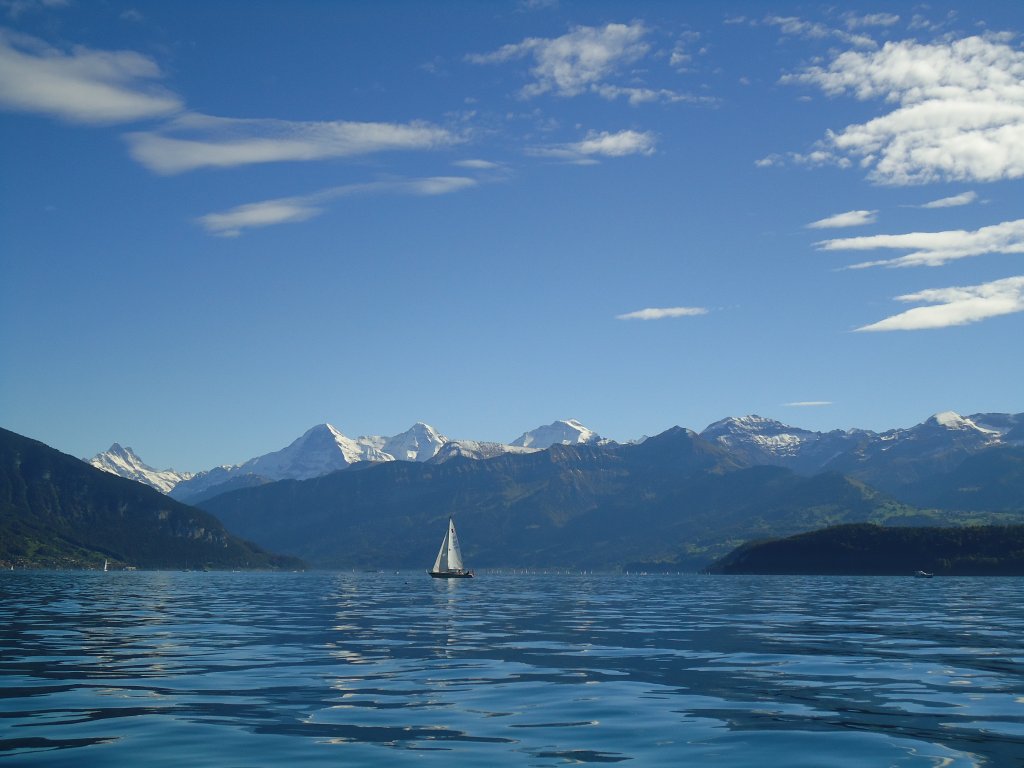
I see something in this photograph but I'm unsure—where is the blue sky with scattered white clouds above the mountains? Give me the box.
[0,0,1024,471]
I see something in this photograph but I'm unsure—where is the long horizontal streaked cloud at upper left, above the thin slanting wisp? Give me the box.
[126,114,462,174]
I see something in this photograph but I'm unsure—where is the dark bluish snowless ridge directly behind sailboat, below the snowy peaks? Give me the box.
[193,428,937,569]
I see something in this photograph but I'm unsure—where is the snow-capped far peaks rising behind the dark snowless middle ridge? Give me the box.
[88,412,1024,504]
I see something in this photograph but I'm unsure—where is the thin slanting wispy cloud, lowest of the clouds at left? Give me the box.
[199,176,477,238]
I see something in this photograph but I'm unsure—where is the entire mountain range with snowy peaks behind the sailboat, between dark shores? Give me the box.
[8,413,1024,570]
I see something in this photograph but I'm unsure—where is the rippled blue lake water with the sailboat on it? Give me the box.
[0,571,1024,768]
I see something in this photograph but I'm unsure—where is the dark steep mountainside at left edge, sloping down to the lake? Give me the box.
[0,429,301,567]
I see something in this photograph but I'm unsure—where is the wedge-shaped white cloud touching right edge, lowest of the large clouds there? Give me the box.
[857,275,1024,332]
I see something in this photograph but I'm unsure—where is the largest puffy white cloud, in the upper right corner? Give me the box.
[782,37,1024,184]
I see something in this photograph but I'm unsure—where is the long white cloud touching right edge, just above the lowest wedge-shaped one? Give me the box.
[815,219,1024,269]
